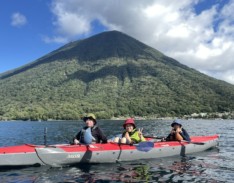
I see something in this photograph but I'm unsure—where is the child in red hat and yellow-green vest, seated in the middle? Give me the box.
[114,118,145,144]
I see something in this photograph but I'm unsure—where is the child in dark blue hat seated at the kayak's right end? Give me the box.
[166,119,191,142]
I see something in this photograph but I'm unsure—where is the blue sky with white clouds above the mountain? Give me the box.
[0,0,234,84]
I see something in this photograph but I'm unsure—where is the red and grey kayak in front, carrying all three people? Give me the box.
[36,136,218,166]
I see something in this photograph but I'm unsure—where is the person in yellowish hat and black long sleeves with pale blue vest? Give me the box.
[73,113,107,144]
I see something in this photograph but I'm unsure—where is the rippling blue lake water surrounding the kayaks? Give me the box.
[0,120,234,183]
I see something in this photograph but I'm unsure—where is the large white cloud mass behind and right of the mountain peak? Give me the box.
[48,0,234,84]
